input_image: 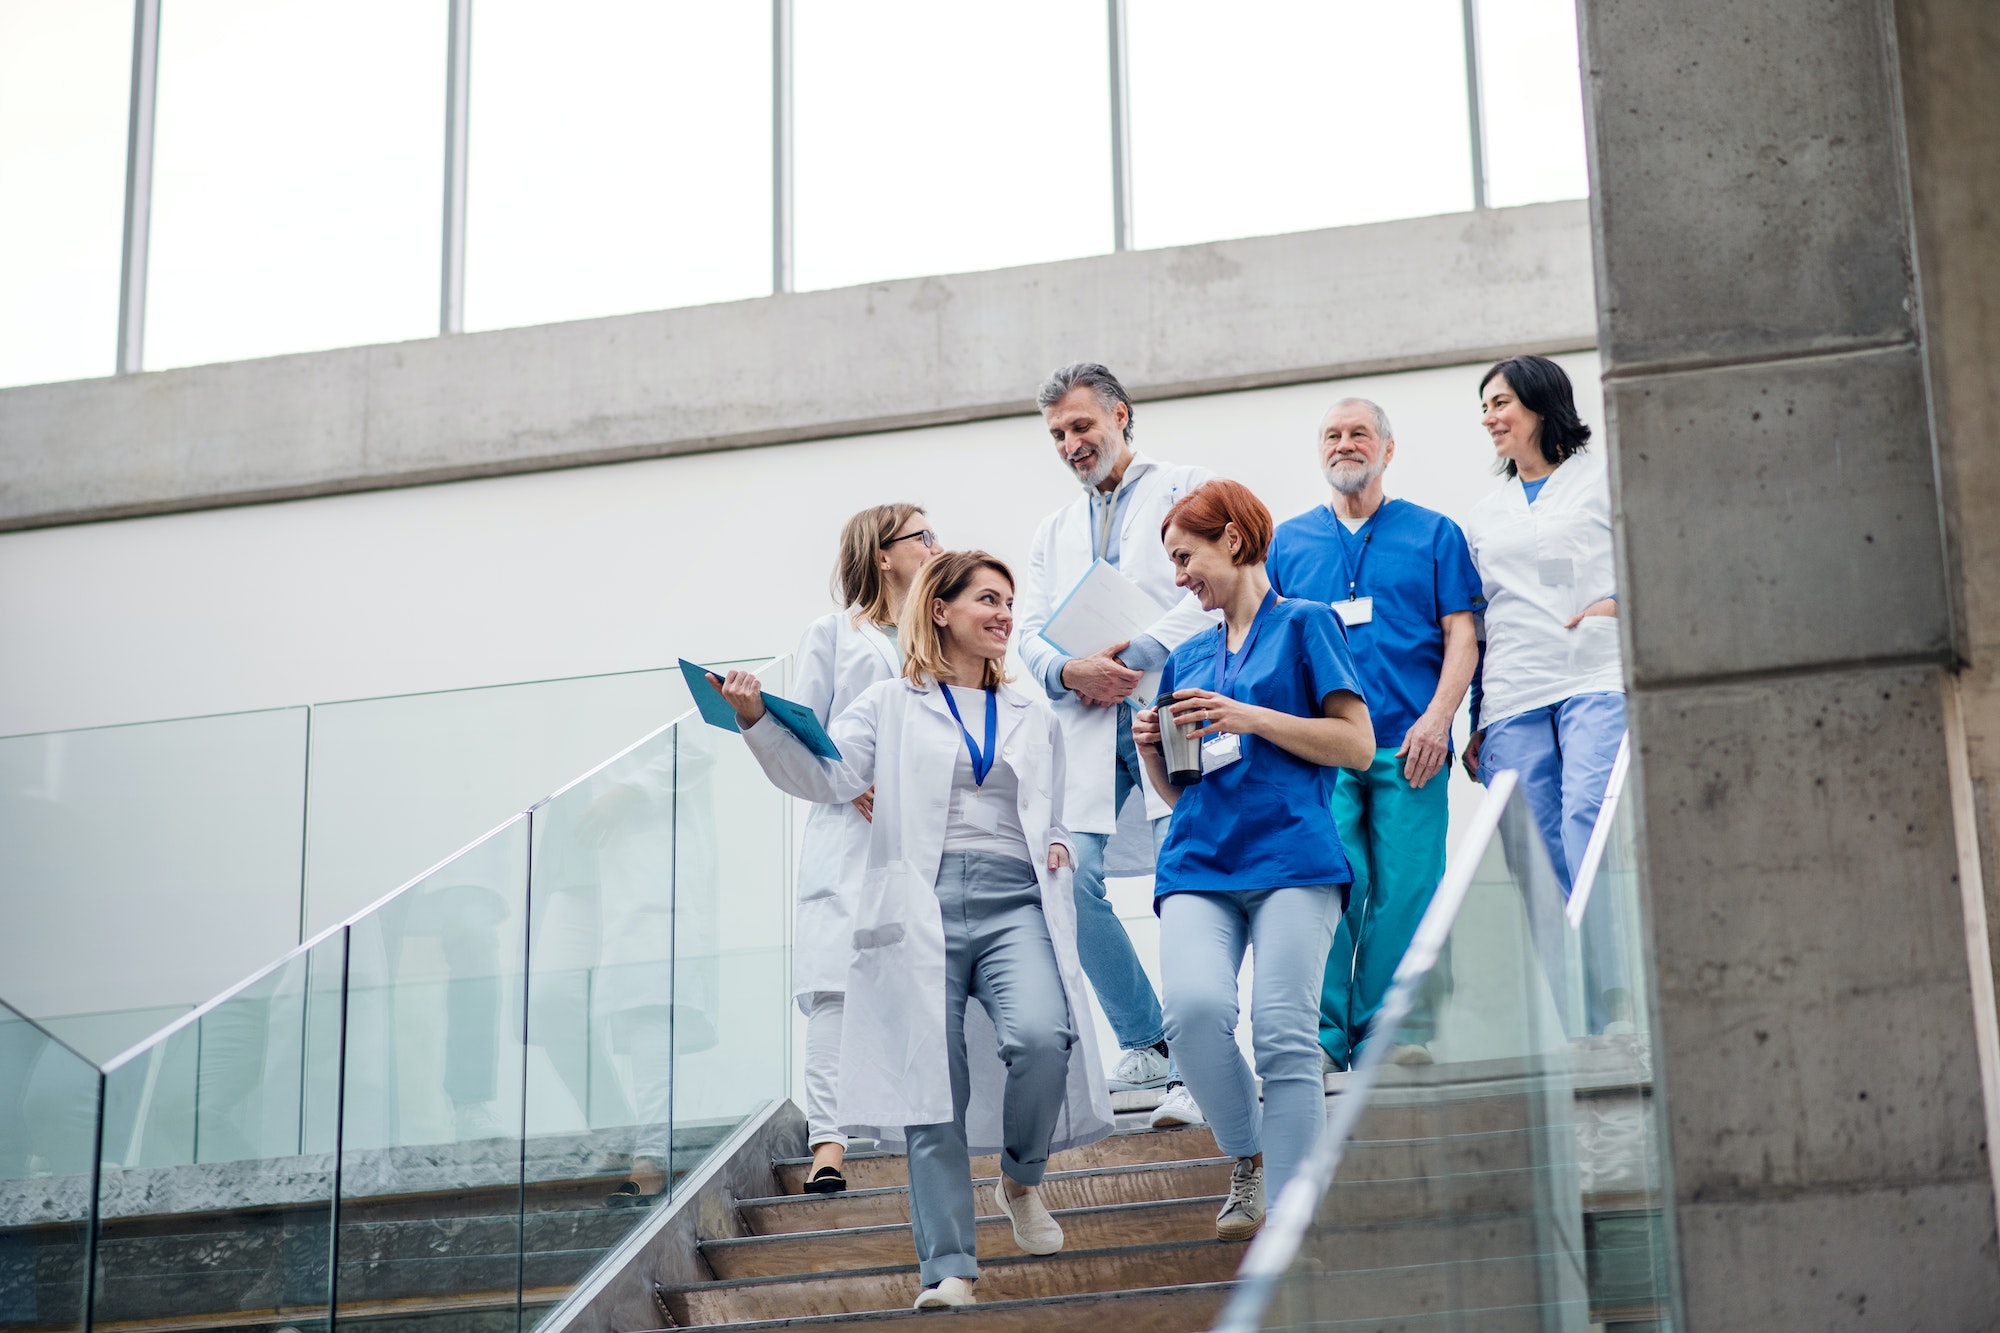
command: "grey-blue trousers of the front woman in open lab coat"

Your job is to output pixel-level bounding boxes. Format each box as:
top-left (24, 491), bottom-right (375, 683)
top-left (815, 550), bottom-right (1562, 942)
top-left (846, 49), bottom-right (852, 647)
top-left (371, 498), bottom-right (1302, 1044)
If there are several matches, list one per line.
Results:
top-left (904, 853), bottom-right (1076, 1287)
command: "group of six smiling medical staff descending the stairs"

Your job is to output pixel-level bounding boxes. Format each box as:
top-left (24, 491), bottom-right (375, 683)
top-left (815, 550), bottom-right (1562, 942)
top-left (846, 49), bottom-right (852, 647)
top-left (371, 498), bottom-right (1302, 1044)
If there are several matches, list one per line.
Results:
top-left (720, 356), bottom-right (1624, 1309)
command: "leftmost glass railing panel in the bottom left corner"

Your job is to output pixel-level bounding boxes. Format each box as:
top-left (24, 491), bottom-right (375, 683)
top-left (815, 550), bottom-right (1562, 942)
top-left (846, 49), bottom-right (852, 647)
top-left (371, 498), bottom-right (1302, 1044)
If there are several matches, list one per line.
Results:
top-left (0, 1005), bottom-right (102, 1333)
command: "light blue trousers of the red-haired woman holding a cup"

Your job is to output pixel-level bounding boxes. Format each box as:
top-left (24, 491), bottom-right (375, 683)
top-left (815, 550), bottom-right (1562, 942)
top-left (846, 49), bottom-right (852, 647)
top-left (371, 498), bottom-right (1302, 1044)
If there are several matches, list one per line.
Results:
top-left (1160, 885), bottom-right (1346, 1201)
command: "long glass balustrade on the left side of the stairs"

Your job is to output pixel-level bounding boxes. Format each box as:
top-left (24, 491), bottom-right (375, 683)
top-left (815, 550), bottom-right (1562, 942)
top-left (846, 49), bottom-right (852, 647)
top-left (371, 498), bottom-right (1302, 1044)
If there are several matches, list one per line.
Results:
top-left (0, 662), bottom-right (790, 1333)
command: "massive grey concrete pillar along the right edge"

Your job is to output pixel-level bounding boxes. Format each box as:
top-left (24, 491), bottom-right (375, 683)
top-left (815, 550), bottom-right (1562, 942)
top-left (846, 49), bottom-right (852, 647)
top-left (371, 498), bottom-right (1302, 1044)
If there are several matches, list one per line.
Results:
top-left (1580, 0), bottom-right (2000, 1333)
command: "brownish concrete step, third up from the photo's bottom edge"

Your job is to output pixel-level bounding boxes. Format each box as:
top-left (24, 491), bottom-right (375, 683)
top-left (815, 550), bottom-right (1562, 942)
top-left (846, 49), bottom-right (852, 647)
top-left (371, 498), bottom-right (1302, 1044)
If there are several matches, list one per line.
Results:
top-left (702, 1189), bottom-right (1222, 1279)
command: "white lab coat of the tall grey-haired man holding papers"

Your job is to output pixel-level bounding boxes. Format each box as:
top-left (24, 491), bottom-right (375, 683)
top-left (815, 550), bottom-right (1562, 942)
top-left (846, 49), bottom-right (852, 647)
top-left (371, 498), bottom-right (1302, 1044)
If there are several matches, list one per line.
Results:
top-left (1014, 452), bottom-right (1216, 833)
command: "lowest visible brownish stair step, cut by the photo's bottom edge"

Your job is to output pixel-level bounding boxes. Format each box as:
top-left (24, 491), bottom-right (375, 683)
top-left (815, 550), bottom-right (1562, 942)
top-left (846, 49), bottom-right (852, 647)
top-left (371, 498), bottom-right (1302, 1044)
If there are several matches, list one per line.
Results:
top-left (678, 1279), bottom-right (1232, 1333)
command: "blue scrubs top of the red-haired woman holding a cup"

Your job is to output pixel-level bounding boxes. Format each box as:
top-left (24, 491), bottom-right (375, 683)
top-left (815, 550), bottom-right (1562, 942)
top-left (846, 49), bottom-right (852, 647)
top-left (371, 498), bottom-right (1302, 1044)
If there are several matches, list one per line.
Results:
top-left (1152, 592), bottom-right (1362, 896)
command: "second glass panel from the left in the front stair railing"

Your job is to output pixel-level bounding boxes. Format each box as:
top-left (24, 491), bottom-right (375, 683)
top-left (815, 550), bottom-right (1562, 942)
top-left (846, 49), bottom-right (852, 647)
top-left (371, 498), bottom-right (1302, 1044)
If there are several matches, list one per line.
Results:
top-left (94, 935), bottom-right (346, 1329)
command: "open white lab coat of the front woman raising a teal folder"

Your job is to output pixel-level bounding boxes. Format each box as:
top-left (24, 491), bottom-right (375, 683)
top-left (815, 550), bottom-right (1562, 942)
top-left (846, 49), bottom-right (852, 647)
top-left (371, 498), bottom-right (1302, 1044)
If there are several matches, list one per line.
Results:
top-left (744, 679), bottom-right (1112, 1153)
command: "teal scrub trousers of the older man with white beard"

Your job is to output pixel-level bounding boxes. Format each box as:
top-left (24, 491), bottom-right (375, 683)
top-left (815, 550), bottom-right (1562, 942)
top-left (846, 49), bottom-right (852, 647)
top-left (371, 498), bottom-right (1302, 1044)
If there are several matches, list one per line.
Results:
top-left (1320, 749), bottom-right (1452, 1069)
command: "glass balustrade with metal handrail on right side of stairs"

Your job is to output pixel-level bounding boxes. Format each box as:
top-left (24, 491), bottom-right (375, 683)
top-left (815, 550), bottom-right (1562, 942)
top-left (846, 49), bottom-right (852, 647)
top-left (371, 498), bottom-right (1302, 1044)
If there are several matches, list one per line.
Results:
top-left (1216, 775), bottom-right (1674, 1333)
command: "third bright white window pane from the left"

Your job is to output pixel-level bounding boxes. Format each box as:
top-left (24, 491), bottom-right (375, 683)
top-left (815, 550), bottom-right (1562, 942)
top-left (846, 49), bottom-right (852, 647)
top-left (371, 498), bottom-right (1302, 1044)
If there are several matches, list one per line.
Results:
top-left (466, 0), bottom-right (772, 328)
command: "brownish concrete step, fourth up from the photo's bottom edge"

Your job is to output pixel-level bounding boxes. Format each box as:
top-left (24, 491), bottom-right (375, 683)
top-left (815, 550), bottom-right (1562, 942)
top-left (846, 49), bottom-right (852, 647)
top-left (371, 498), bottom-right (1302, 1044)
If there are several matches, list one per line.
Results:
top-left (736, 1157), bottom-right (1234, 1235)
